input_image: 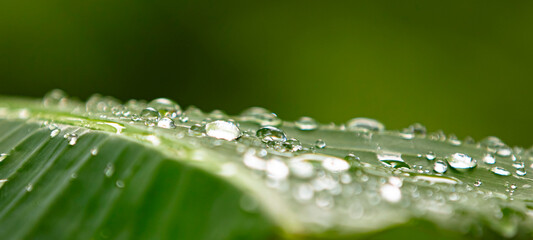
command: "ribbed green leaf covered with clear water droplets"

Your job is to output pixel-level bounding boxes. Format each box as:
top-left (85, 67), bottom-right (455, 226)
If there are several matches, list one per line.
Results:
top-left (0, 91), bottom-right (533, 239)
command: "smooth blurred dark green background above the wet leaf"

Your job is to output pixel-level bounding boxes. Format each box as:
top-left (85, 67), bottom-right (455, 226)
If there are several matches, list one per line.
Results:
top-left (0, 0), bottom-right (533, 147)
